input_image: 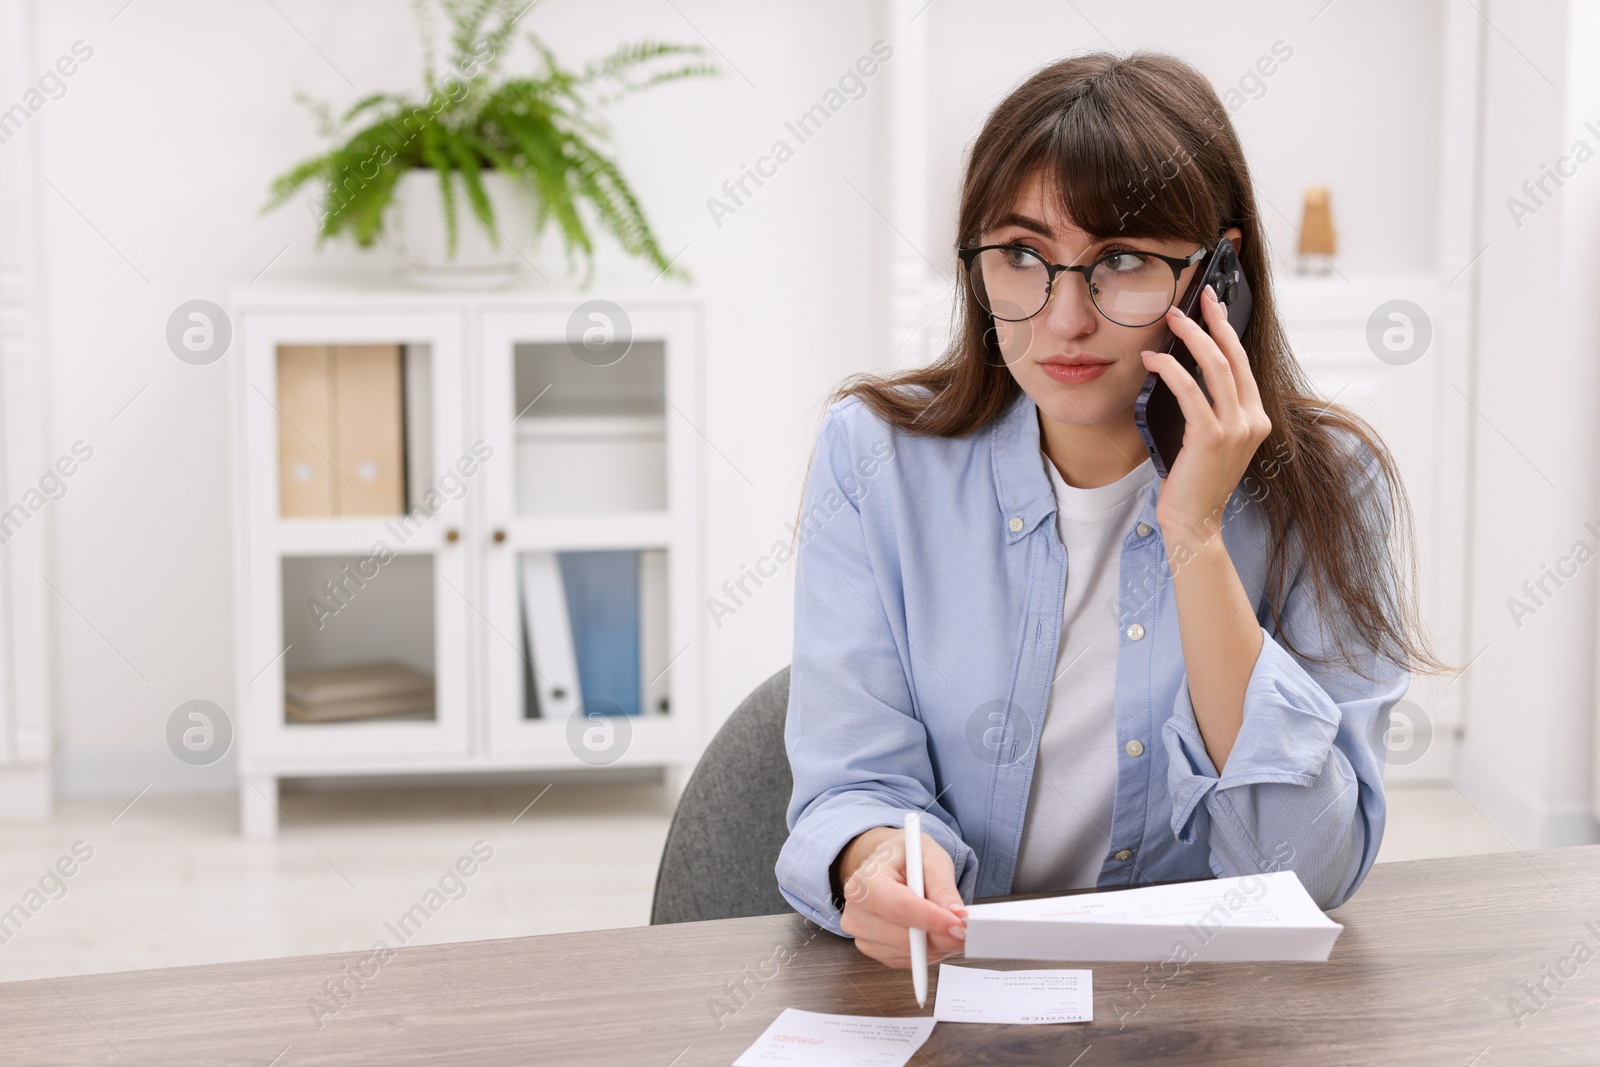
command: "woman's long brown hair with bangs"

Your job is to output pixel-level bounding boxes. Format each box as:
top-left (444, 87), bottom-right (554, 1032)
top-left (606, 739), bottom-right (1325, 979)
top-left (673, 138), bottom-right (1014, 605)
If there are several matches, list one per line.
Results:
top-left (830, 53), bottom-right (1458, 675)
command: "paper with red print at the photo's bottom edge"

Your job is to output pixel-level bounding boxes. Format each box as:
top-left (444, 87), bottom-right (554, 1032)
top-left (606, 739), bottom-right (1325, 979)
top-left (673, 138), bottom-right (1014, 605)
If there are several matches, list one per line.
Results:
top-left (733, 1011), bottom-right (942, 1067)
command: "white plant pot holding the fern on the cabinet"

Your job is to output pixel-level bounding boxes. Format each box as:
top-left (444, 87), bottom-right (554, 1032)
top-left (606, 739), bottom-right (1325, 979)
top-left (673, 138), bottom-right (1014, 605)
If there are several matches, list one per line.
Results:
top-left (394, 168), bottom-right (552, 290)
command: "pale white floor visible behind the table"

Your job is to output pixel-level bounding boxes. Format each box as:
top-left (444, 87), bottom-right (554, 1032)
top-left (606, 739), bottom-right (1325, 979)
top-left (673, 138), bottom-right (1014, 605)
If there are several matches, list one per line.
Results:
top-left (0, 781), bottom-right (1512, 981)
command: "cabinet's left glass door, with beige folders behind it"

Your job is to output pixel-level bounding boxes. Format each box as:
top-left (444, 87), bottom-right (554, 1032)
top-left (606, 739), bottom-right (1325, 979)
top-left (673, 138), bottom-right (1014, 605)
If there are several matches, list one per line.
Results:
top-left (242, 310), bottom-right (480, 771)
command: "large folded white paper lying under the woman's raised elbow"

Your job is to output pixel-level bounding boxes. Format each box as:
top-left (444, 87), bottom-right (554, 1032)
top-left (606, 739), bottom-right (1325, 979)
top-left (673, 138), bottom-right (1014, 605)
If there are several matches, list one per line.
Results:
top-left (965, 870), bottom-right (1344, 963)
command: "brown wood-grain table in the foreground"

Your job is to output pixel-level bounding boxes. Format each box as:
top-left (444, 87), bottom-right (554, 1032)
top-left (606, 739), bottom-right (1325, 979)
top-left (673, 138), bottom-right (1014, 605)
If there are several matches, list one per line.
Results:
top-left (0, 846), bottom-right (1600, 1067)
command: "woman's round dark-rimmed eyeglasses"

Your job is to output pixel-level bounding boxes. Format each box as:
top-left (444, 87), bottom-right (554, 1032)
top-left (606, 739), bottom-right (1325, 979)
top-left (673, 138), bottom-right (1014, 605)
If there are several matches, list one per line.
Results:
top-left (957, 245), bottom-right (1206, 326)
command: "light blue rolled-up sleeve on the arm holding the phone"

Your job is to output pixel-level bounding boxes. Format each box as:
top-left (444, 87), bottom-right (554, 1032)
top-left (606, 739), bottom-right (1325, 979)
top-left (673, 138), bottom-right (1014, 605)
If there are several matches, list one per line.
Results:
top-left (1162, 461), bottom-right (1411, 909)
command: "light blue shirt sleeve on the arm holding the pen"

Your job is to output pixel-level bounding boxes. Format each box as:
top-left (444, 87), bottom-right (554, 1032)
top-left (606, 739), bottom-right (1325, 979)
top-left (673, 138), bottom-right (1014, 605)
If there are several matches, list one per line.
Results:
top-left (774, 400), bottom-right (978, 936)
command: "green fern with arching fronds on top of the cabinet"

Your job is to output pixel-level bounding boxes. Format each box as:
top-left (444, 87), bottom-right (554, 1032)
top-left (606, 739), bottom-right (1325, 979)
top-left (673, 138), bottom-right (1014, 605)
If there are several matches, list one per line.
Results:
top-left (262, 0), bottom-right (720, 283)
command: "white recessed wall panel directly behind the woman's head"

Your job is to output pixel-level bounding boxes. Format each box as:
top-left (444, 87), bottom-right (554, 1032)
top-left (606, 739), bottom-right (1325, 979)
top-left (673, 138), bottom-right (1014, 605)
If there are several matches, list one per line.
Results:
top-left (925, 0), bottom-right (1440, 274)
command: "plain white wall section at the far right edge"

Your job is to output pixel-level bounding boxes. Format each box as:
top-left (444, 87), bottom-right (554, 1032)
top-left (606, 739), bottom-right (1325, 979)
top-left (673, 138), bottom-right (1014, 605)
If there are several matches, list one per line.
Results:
top-left (1458, 0), bottom-right (1600, 848)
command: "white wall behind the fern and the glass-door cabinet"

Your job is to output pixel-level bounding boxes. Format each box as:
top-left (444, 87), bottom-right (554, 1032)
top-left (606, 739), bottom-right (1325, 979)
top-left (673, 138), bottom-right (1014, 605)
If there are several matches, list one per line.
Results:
top-left (22, 0), bottom-right (882, 792)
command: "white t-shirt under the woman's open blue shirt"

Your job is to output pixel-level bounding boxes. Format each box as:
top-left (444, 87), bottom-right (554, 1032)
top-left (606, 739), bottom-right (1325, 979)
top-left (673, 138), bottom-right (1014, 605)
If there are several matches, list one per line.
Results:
top-left (1011, 453), bottom-right (1157, 893)
